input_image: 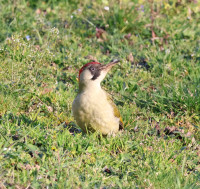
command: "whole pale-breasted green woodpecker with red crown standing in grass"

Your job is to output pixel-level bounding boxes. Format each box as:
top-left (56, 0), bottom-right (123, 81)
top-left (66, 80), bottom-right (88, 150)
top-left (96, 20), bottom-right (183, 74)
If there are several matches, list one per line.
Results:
top-left (72, 60), bottom-right (124, 135)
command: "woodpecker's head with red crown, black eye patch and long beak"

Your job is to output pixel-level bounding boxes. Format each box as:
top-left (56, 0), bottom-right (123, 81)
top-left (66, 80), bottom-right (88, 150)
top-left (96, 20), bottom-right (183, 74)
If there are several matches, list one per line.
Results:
top-left (79, 60), bottom-right (119, 89)
